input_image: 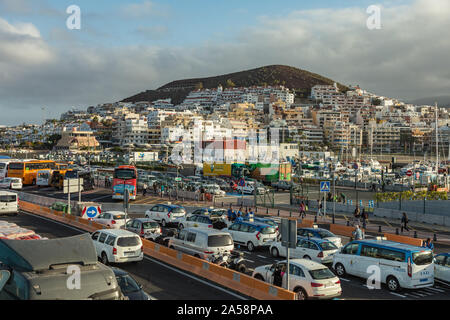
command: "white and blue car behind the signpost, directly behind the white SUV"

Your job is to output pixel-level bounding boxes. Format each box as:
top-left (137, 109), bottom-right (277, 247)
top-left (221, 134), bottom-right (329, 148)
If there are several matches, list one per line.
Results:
top-left (269, 237), bottom-right (339, 264)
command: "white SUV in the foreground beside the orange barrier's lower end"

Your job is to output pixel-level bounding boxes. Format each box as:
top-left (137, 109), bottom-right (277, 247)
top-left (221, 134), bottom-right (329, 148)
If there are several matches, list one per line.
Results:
top-left (252, 259), bottom-right (342, 300)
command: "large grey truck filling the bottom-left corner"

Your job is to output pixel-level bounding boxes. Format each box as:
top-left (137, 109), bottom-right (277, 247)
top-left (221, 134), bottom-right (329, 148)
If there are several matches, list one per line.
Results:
top-left (0, 233), bottom-right (125, 300)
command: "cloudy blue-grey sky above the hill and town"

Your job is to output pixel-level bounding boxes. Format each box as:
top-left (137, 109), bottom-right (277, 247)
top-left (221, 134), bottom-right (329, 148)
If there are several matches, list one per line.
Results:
top-left (0, 0), bottom-right (450, 125)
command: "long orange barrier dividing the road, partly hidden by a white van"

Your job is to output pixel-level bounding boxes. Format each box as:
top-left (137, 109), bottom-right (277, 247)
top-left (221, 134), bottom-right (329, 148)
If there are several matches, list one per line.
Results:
top-left (20, 200), bottom-right (295, 300)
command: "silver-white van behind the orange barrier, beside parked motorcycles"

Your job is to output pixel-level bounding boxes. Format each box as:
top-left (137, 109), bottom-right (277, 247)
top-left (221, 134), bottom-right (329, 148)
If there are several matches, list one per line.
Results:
top-left (169, 228), bottom-right (234, 260)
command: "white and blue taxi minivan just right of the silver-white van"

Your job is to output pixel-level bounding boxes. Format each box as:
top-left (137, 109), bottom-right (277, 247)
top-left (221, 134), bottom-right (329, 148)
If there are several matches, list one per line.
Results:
top-left (222, 221), bottom-right (278, 251)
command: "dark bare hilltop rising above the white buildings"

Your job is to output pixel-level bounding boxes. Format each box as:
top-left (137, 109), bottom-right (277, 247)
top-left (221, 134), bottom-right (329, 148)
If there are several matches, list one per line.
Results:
top-left (123, 65), bottom-right (348, 104)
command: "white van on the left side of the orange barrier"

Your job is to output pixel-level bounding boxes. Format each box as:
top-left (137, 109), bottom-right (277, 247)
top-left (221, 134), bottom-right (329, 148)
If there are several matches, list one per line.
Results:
top-left (91, 229), bottom-right (144, 264)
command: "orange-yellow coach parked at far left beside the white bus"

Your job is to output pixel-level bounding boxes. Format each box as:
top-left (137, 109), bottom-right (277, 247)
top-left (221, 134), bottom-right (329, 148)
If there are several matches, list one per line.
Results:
top-left (8, 160), bottom-right (56, 185)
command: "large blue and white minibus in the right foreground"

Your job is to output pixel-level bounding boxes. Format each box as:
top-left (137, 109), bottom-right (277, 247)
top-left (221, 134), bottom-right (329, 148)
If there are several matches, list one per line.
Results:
top-left (333, 238), bottom-right (434, 292)
